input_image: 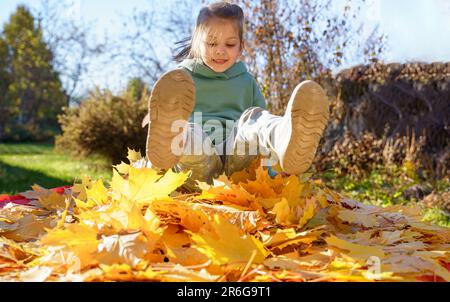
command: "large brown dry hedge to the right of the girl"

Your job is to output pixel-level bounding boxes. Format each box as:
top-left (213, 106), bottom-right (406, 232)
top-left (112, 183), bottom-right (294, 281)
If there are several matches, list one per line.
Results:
top-left (319, 62), bottom-right (450, 179)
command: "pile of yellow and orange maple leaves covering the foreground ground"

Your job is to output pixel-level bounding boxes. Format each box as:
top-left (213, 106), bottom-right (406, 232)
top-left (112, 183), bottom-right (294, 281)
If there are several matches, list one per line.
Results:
top-left (0, 150), bottom-right (450, 281)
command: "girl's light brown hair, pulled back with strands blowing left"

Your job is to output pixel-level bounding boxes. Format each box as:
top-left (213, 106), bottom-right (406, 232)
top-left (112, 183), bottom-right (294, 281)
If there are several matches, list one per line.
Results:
top-left (173, 1), bottom-right (244, 62)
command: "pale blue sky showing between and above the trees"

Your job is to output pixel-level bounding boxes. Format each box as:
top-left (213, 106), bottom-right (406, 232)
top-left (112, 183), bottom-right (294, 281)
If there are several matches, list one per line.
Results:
top-left (0, 0), bottom-right (450, 94)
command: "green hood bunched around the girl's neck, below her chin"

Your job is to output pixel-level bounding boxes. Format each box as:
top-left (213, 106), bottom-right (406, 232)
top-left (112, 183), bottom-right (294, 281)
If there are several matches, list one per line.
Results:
top-left (179, 59), bottom-right (247, 80)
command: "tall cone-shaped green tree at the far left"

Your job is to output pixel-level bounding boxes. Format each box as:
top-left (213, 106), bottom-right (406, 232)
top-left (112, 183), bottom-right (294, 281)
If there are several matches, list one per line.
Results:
top-left (3, 6), bottom-right (67, 139)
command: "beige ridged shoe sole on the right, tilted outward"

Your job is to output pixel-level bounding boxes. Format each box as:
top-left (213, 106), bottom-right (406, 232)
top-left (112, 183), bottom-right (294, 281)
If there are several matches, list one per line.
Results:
top-left (280, 81), bottom-right (330, 174)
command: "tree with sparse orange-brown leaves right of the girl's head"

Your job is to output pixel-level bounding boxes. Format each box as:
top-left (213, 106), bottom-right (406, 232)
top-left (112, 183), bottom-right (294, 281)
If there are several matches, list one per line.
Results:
top-left (236, 0), bottom-right (385, 114)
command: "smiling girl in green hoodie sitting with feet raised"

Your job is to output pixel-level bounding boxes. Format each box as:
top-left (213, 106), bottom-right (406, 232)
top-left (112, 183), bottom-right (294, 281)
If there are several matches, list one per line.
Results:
top-left (147, 2), bottom-right (329, 190)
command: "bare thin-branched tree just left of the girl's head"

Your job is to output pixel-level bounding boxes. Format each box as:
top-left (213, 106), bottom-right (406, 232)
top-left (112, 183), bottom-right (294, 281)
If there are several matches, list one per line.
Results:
top-left (108, 0), bottom-right (200, 87)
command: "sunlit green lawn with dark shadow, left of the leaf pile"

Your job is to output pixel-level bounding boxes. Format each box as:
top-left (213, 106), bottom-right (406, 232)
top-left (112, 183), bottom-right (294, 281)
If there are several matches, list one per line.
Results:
top-left (0, 143), bottom-right (112, 195)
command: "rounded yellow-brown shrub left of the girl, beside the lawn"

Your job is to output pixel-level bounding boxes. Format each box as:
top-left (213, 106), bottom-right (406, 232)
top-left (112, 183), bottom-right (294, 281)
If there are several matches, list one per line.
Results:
top-left (56, 91), bottom-right (148, 163)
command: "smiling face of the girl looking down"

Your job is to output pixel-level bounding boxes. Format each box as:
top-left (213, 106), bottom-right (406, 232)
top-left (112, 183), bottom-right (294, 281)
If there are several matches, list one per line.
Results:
top-left (200, 19), bottom-right (242, 72)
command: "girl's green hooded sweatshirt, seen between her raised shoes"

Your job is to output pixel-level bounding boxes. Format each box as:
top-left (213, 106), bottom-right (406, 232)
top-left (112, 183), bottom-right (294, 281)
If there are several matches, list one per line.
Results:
top-left (179, 59), bottom-right (267, 144)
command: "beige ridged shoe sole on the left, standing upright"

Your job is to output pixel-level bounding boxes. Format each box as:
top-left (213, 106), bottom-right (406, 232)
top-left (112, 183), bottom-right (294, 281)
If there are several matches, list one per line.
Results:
top-left (146, 69), bottom-right (195, 169)
